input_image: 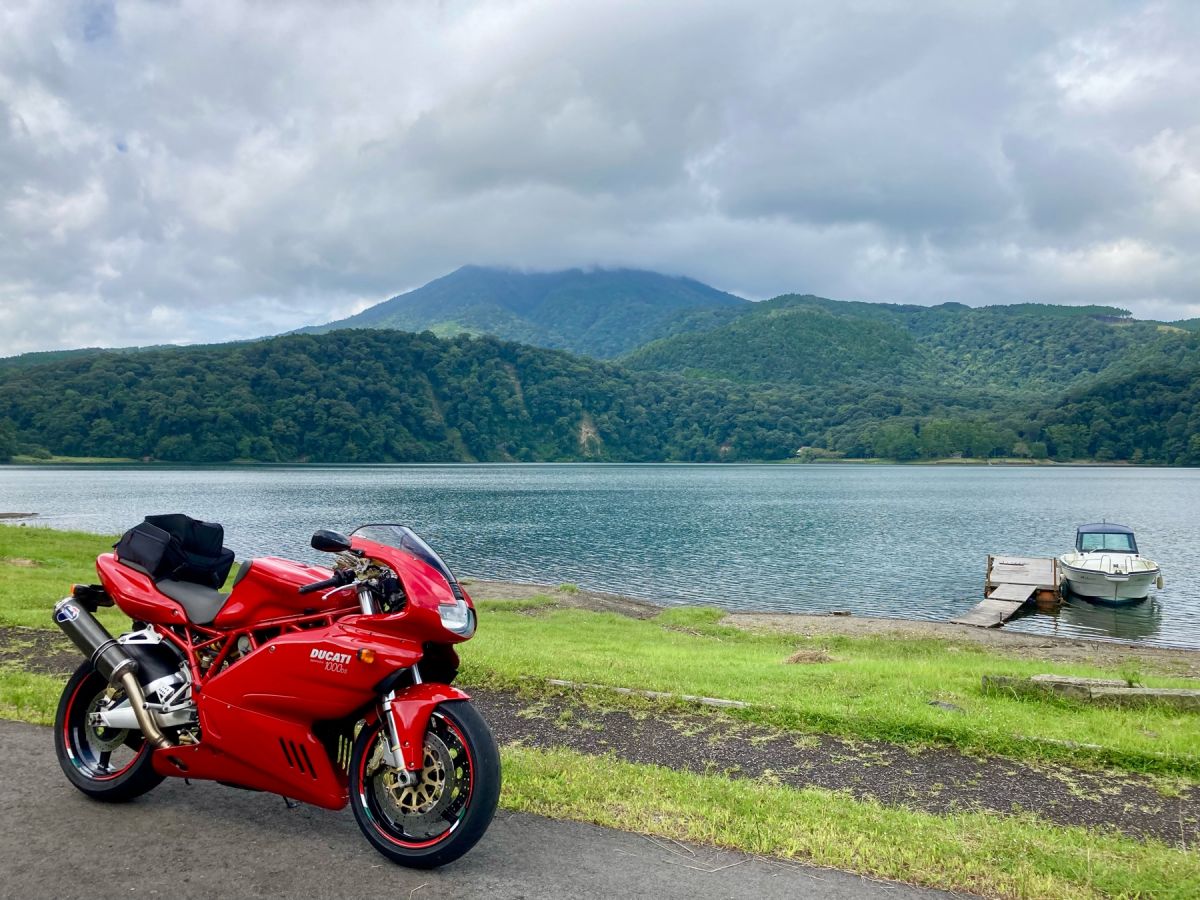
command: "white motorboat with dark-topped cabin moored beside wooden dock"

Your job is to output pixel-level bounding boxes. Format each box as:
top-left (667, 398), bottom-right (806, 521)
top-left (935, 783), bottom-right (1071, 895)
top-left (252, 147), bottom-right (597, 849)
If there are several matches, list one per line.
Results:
top-left (1058, 522), bottom-right (1163, 604)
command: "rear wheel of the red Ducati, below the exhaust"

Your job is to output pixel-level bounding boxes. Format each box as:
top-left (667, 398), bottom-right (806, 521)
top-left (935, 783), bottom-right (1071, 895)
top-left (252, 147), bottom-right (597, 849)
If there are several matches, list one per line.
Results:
top-left (54, 662), bottom-right (163, 803)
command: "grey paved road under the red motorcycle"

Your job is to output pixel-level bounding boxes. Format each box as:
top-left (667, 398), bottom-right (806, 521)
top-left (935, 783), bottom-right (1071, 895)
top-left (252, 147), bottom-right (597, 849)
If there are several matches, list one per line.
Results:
top-left (0, 721), bottom-right (942, 900)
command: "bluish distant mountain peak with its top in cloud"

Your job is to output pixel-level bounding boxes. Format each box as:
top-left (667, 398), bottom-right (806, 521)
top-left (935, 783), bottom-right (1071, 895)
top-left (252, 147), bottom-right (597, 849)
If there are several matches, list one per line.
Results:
top-left (302, 265), bottom-right (749, 359)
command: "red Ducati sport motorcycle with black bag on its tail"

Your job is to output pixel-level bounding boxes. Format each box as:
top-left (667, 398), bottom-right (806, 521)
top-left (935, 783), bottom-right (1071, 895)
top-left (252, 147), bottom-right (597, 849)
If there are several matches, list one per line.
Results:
top-left (54, 516), bottom-right (500, 868)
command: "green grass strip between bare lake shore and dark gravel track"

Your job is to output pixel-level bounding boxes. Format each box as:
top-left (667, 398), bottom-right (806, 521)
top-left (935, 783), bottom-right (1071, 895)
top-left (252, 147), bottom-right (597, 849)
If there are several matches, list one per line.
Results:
top-left (462, 601), bottom-right (1200, 780)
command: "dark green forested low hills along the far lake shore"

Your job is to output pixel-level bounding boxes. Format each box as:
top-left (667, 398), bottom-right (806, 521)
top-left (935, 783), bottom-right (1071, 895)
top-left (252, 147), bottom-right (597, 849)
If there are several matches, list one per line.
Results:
top-left (0, 324), bottom-right (1200, 466)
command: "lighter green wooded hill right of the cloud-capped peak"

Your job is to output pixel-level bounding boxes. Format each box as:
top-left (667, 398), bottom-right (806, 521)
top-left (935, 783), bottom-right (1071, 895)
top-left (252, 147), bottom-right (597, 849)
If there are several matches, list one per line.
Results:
top-left (622, 295), bottom-right (1200, 396)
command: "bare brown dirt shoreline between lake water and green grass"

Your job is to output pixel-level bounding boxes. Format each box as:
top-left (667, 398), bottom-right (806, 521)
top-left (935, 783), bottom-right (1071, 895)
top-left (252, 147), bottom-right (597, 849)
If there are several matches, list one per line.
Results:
top-left (461, 576), bottom-right (1200, 678)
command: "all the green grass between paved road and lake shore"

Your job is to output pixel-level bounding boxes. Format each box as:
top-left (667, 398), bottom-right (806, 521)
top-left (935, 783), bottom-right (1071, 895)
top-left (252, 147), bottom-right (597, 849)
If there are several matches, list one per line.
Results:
top-left (0, 526), bottom-right (1200, 898)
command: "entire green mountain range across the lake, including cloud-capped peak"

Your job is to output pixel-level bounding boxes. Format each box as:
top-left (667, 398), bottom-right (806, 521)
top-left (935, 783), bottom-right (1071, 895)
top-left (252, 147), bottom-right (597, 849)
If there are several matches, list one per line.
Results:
top-left (7, 269), bottom-right (1200, 464)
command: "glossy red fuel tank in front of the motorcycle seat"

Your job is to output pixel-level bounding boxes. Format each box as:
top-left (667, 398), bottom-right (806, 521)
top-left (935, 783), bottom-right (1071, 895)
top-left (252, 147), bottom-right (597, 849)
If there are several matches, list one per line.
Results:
top-left (212, 557), bottom-right (358, 629)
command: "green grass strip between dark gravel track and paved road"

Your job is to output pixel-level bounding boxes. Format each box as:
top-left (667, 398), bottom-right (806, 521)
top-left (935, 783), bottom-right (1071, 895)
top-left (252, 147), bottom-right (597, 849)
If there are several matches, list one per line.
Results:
top-left (502, 745), bottom-right (1200, 898)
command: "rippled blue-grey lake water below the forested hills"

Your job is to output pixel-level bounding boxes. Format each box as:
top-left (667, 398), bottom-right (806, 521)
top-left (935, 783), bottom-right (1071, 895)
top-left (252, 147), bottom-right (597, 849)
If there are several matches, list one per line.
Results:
top-left (0, 464), bottom-right (1200, 647)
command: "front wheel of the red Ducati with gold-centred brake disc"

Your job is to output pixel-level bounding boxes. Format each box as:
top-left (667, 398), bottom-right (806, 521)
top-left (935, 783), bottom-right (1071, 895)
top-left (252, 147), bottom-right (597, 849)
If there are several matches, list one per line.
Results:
top-left (350, 700), bottom-right (500, 869)
